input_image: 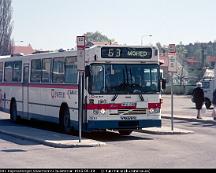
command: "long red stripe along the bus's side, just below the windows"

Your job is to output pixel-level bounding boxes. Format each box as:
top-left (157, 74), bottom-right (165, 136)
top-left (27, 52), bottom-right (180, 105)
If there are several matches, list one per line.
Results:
top-left (0, 83), bottom-right (78, 89)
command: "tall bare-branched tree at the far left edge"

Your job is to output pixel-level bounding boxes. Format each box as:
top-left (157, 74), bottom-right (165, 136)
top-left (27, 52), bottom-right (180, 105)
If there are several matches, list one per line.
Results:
top-left (0, 0), bottom-right (13, 55)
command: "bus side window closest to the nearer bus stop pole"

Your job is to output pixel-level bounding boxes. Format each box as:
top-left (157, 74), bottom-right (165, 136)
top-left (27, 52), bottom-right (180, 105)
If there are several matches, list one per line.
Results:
top-left (65, 57), bottom-right (77, 84)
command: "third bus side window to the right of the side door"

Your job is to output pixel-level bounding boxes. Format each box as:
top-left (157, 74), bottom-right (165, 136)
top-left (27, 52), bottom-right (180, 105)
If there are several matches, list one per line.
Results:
top-left (52, 57), bottom-right (65, 83)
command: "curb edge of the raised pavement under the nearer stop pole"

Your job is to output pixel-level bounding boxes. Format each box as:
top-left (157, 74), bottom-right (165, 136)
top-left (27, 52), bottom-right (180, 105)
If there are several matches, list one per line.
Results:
top-left (0, 129), bottom-right (106, 148)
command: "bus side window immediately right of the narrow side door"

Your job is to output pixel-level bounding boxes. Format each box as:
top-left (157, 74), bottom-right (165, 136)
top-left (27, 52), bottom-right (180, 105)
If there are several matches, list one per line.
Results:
top-left (31, 59), bottom-right (41, 83)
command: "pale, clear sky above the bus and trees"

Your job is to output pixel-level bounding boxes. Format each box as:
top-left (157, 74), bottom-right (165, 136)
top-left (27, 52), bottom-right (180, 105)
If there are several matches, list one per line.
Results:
top-left (12, 0), bottom-right (216, 50)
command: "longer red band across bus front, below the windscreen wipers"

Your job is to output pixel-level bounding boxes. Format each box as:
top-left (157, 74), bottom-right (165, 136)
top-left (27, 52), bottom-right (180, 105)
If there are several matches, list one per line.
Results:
top-left (86, 104), bottom-right (136, 110)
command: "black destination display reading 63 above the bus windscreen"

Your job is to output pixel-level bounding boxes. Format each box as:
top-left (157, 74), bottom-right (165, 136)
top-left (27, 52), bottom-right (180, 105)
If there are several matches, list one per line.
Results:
top-left (101, 47), bottom-right (152, 59)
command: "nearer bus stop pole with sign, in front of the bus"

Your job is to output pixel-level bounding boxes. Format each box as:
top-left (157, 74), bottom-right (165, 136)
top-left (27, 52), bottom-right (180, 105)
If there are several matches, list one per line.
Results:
top-left (77, 36), bottom-right (85, 143)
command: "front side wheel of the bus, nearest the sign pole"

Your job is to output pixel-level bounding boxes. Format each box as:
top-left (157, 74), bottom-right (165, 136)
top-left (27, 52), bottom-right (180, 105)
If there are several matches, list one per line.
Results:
top-left (59, 106), bottom-right (71, 133)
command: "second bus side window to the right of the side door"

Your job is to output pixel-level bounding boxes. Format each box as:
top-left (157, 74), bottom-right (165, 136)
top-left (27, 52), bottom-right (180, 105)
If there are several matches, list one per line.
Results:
top-left (42, 58), bottom-right (52, 83)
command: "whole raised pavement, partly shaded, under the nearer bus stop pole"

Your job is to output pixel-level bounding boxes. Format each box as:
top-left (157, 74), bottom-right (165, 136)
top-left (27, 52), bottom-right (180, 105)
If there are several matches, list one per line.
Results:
top-left (0, 124), bottom-right (105, 148)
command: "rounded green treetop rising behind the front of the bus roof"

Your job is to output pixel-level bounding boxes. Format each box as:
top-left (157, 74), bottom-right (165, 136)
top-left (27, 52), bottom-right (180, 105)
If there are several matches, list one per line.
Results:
top-left (84, 31), bottom-right (114, 43)
